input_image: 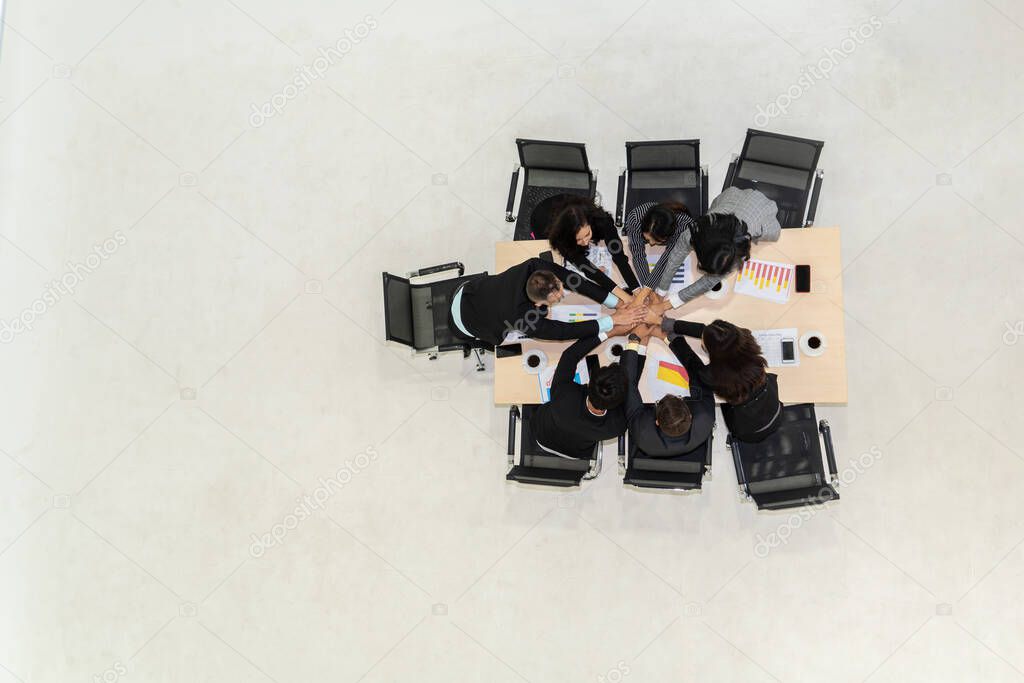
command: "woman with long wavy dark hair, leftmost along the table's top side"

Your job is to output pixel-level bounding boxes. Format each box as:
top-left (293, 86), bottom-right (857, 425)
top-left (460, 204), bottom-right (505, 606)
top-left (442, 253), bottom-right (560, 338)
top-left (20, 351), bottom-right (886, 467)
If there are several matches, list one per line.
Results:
top-left (548, 195), bottom-right (639, 303)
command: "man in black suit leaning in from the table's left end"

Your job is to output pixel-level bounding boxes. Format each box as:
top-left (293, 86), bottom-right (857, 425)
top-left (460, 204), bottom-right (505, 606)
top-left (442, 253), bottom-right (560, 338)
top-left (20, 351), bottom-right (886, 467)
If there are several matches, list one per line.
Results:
top-left (449, 258), bottom-right (646, 346)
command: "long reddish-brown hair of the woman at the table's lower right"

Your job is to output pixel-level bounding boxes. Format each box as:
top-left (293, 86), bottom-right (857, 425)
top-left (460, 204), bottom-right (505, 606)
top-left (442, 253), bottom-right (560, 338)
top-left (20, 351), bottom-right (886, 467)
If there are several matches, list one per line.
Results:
top-left (702, 321), bottom-right (768, 405)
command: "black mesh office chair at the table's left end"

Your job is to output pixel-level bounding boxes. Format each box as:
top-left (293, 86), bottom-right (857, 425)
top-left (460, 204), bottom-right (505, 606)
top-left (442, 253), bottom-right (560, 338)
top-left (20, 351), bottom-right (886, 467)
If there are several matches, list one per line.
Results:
top-left (383, 261), bottom-right (492, 372)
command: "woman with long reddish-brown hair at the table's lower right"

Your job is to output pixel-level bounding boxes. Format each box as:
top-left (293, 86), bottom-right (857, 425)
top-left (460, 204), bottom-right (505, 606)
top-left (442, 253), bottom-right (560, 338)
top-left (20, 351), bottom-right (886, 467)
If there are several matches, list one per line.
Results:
top-left (662, 317), bottom-right (782, 441)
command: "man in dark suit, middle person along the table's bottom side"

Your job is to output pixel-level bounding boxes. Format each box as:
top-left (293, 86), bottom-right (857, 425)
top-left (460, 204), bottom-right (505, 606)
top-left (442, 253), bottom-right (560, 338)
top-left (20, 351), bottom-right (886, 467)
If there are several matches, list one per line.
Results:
top-left (622, 328), bottom-right (715, 458)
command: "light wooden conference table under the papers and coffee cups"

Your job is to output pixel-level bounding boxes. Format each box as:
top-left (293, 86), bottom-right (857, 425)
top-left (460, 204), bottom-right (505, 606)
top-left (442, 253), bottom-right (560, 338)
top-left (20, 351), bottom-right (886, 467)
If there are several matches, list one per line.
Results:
top-left (495, 227), bottom-right (847, 404)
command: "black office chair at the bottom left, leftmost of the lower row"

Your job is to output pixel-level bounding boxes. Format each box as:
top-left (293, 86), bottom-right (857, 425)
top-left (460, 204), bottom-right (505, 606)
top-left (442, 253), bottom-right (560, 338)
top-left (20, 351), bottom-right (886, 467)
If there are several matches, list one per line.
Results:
top-left (505, 405), bottom-right (601, 486)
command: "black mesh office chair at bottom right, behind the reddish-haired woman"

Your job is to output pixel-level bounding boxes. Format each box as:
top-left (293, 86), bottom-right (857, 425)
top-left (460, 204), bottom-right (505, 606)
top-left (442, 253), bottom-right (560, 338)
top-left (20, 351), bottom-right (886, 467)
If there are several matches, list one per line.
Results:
top-left (727, 403), bottom-right (839, 510)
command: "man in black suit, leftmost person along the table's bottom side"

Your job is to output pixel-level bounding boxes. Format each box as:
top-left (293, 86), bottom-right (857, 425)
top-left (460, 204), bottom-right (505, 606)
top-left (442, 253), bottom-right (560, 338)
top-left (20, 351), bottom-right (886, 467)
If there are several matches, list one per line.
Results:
top-left (532, 335), bottom-right (627, 460)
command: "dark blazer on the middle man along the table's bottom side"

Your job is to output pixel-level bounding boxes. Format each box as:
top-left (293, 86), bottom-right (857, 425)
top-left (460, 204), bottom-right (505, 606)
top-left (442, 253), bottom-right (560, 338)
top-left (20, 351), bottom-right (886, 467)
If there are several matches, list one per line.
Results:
top-left (622, 337), bottom-right (715, 458)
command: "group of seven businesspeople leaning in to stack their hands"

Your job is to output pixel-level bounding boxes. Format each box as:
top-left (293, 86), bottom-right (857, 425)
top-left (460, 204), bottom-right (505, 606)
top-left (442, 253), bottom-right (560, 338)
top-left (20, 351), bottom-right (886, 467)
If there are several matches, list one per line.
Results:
top-left (449, 187), bottom-right (781, 459)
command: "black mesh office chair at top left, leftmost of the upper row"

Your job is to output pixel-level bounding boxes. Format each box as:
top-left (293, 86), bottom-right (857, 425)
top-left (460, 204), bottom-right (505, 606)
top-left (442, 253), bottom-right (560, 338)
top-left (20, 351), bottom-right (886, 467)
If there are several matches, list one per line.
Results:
top-left (505, 138), bottom-right (597, 240)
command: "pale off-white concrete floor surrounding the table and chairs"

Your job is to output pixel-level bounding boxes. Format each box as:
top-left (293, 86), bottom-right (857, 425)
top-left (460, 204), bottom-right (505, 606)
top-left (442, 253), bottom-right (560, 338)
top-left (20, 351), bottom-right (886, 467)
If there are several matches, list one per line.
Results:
top-left (0, 0), bottom-right (1024, 683)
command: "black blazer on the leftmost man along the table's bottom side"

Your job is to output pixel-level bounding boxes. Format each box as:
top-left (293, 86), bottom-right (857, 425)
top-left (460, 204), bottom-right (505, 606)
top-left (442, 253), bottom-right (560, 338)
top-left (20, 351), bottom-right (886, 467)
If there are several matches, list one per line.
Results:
top-left (532, 336), bottom-right (626, 459)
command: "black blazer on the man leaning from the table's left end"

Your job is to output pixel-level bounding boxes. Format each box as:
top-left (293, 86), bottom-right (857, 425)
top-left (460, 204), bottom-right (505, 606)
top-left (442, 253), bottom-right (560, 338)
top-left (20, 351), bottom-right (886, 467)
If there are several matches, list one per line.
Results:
top-left (460, 258), bottom-right (610, 345)
